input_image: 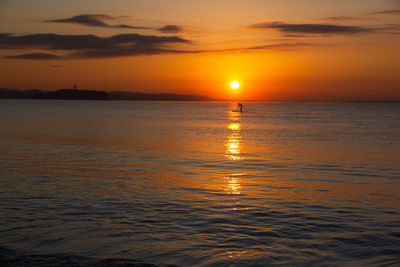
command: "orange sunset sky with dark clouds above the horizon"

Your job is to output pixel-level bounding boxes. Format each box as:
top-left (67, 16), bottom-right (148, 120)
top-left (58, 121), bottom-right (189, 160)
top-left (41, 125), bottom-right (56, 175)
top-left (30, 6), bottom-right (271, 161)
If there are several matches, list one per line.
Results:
top-left (0, 0), bottom-right (400, 101)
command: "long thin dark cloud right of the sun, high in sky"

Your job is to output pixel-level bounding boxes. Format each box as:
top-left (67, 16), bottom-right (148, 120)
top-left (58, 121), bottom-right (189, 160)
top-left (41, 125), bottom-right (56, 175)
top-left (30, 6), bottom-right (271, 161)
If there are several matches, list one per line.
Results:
top-left (249, 21), bottom-right (373, 35)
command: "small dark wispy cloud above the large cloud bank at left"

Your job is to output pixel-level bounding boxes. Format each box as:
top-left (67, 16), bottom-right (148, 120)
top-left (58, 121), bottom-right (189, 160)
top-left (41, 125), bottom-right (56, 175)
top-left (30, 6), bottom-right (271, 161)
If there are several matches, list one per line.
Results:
top-left (45, 14), bottom-right (147, 29)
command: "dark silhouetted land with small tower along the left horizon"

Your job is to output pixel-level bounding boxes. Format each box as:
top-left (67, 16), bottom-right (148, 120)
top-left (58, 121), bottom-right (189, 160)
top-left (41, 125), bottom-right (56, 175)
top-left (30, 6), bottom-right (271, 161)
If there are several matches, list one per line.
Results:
top-left (0, 88), bottom-right (215, 101)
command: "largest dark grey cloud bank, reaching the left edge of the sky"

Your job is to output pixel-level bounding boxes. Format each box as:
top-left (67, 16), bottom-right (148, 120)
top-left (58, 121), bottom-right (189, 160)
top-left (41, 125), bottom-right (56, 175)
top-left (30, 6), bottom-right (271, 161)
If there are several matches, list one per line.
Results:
top-left (0, 34), bottom-right (191, 59)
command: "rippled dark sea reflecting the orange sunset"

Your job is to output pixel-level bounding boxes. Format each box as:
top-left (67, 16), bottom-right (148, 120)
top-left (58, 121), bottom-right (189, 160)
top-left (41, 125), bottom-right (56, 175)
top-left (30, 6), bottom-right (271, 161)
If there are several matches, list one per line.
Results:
top-left (0, 100), bottom-right (400, 266)
